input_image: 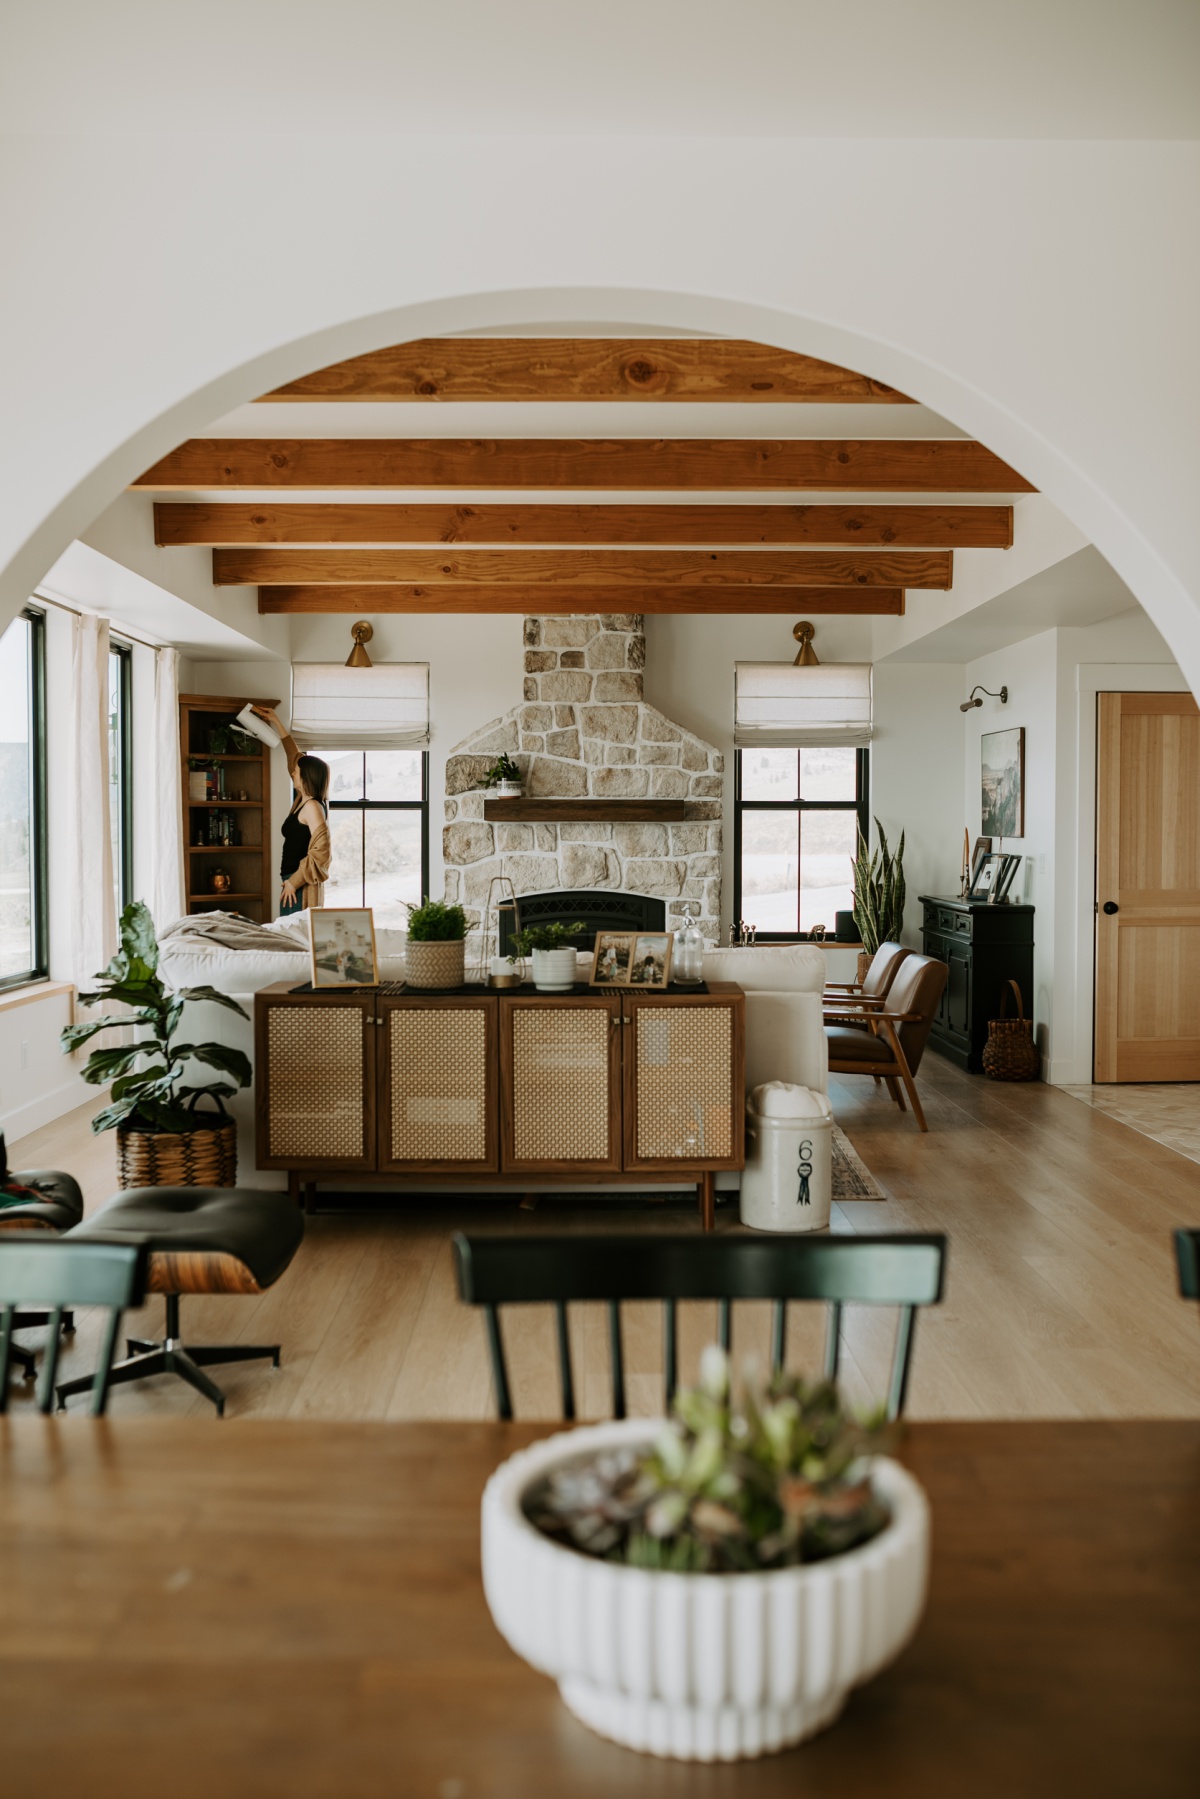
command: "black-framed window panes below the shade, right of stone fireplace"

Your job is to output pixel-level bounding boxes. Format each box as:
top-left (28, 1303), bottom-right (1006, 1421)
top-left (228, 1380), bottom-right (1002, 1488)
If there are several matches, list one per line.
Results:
top-left (734, 747), bottom-right (869, 943)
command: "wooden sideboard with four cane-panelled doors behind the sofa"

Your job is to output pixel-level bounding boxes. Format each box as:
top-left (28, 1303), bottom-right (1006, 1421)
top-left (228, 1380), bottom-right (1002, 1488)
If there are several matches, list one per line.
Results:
top-left (254, 982), bottom-right (745, 1227)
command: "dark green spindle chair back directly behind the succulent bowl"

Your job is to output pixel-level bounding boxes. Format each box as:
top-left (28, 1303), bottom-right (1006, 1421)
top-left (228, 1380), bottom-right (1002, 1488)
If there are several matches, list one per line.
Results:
top-left (453, 1232), bottom-right (946, 1419)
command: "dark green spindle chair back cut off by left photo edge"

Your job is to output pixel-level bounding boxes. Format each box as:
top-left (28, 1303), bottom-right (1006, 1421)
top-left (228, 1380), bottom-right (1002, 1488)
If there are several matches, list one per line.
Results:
top-left (0, 1232), bottom-right (149, 1418)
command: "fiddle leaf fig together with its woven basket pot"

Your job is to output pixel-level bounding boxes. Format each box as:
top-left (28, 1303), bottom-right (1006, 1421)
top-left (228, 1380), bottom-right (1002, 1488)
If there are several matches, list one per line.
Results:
top-left (59, 900), bottom-right (250, 1187)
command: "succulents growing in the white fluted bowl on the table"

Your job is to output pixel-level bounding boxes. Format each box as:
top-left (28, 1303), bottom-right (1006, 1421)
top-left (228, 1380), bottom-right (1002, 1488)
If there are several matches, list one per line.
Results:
top-left (524, 1347), bottom-right (894, 1574)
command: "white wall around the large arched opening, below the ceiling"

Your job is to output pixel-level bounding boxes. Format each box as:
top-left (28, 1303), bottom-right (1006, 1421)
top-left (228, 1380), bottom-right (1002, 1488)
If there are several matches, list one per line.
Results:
top-left (0, 138), bottom-right (1200, 682)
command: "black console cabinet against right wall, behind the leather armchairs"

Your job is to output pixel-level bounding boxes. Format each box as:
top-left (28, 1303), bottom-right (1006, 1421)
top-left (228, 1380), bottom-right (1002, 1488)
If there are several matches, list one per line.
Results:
top-left (921, 894), bottom-right (1033, 1072)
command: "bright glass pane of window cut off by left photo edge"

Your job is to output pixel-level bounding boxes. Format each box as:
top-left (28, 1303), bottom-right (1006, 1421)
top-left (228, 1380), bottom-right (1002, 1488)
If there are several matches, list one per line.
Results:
top-left (0, 619), bottom-right (36, 980)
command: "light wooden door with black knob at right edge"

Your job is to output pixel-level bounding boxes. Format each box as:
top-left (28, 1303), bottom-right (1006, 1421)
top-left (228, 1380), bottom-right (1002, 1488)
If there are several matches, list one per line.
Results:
top-left (1094, 693), bottom-right (1200, 1081)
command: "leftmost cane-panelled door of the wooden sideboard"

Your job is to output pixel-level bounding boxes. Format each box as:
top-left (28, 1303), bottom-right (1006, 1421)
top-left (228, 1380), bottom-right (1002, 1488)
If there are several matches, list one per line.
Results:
top-left (254, 993), bottom-right (378, 1173)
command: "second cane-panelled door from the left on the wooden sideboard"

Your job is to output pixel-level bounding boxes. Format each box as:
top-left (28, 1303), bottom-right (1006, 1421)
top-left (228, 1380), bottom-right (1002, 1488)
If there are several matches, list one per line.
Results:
top-left (378, 995), bottom-right (500, 1175)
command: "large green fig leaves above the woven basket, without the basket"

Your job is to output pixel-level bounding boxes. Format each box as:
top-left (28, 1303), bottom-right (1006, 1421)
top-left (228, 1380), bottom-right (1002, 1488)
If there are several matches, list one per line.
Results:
top-left (59, 900), bottom-right (252, 1132)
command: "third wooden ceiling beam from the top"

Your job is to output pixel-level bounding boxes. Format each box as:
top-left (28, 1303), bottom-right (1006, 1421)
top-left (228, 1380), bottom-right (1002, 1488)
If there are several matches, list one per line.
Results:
top-left (155, 500), bottom-right (1013, 550)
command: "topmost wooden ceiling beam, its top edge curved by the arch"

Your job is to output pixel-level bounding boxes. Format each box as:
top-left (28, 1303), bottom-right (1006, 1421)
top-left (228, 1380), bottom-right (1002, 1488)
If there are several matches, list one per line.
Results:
top-left (253, 338), bottom-right (912, 407)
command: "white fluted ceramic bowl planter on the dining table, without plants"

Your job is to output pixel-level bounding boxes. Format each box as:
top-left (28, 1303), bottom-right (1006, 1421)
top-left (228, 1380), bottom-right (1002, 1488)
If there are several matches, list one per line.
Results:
top-left (482, 1418), bottom-right (928, 1761)
